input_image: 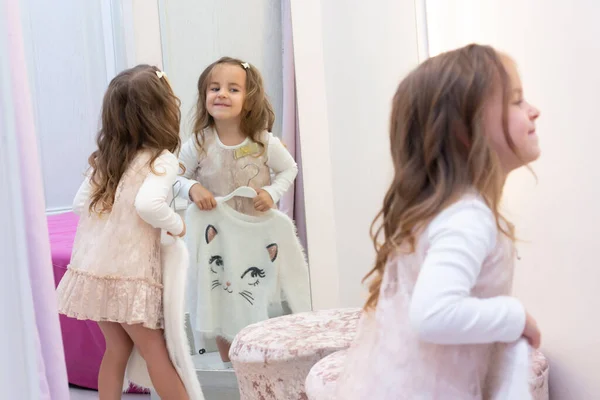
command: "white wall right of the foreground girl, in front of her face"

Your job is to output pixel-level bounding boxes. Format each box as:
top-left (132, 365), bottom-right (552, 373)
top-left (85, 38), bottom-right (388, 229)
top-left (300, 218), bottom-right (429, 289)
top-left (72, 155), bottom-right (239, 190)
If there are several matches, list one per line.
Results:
top-left (427, 0), bottom-right (600, 400)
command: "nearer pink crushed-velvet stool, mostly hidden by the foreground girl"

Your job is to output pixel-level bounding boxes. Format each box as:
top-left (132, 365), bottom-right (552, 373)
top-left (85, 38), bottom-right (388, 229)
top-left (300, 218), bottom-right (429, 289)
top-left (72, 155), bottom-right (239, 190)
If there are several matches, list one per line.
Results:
top-left (306, 350), bottom-right (549, 400)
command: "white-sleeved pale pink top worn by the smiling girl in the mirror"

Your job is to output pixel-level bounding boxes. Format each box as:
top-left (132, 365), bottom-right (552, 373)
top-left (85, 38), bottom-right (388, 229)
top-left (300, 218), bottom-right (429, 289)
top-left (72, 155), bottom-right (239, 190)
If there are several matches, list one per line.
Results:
top-left (179, 129), bottom-right (298, 203)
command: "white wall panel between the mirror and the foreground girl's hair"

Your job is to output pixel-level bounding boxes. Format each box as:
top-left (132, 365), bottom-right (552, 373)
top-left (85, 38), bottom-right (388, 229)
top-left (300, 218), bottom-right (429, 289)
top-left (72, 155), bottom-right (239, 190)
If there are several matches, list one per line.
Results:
top-left (318, 0), bottom-right (418, 306)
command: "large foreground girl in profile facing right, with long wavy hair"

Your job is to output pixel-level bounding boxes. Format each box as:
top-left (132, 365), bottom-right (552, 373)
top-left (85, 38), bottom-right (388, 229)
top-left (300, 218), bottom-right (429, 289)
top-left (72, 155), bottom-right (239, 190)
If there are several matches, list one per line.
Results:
top-left (337, 45), bottom-right (540, 400)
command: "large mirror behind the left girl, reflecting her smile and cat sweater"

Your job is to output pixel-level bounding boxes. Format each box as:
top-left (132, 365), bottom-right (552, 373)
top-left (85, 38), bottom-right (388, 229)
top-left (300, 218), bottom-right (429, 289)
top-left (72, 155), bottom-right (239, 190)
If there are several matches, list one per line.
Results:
top-left (22, 0), bottom-right (316, 391)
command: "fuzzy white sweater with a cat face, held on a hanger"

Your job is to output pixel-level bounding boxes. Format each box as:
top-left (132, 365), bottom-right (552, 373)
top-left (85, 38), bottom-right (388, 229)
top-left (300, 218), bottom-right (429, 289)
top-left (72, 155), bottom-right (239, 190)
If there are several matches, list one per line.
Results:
top-left (186, 203), bottom-right (311, 340)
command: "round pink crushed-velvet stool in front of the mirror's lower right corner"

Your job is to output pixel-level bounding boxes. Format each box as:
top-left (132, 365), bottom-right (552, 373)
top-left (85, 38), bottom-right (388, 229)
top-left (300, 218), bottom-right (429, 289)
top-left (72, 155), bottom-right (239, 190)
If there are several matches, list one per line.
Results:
top-left (229, 308), bottom-right (361, 400)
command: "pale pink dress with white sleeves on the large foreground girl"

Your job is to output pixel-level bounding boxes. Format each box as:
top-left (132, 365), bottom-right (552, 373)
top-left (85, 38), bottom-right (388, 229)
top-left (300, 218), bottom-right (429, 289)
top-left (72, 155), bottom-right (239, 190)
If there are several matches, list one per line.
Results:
top-left (334, 195), bottom-right (531, 400)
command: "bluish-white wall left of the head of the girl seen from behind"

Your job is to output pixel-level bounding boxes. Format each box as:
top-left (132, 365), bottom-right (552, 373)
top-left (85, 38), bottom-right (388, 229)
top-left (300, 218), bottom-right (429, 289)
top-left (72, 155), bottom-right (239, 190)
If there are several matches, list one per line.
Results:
top-left (22, 0), bottom-right (107, 211)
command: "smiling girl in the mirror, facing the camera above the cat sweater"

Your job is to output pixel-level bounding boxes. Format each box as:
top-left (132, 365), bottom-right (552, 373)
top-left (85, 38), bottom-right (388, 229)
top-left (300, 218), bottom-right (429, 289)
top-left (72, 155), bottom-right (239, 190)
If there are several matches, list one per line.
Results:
top-left (179, 57), bottom-right (298, 215)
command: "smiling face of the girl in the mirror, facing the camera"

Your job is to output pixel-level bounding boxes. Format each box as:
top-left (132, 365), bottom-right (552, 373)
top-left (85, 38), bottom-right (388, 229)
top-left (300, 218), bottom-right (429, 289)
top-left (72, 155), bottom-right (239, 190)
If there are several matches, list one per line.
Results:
top-left (206, 64), bottom-right (246, 121)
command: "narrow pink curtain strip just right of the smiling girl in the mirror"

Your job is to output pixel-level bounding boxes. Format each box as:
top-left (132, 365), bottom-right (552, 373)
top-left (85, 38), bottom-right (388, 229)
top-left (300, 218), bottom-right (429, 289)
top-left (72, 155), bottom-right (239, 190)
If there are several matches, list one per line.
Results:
top-left (280, 0), bottom-right (306, 248)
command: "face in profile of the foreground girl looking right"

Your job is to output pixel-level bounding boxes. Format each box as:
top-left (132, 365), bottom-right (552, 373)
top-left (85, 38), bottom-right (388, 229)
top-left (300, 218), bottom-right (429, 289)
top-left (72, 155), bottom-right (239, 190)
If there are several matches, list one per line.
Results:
top-left (484, 57), bottom-right (540, 174)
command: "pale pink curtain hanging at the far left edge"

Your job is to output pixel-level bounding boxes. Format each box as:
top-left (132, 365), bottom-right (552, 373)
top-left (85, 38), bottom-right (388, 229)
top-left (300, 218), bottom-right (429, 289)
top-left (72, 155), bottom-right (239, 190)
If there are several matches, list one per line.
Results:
top-left (0, 0), bottom-right (69, 400)
